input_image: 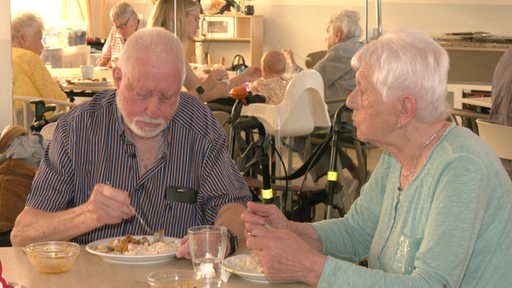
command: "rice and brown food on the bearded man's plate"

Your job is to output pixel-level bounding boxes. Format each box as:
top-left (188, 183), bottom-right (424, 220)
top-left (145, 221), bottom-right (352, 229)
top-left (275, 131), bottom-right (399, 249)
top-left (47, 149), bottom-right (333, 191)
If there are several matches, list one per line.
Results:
top-left (95, 235), bottom-right (180, 255)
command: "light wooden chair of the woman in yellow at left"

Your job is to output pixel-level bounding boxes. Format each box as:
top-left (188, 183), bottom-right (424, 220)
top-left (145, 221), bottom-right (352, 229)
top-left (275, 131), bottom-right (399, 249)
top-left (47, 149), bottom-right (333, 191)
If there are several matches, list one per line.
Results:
top-left (13, 95), bottom-right (77, 131)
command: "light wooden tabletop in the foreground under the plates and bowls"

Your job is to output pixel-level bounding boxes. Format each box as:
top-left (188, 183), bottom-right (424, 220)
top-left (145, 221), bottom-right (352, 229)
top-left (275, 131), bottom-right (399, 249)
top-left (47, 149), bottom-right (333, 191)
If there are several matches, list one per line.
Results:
top-left (0, 246), bottom-right (307, 288)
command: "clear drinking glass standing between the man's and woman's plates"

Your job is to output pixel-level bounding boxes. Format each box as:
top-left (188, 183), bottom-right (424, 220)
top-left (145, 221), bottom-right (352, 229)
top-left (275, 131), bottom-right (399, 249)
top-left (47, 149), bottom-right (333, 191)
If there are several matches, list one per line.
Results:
top-left (188, 225), bottom-right (228, 287)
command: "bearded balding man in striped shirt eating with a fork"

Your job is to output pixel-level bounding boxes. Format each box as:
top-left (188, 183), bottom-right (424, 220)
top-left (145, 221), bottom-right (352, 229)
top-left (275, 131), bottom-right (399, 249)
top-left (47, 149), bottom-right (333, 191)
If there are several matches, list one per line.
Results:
top-left (11, 28), bottom-right (252, 256)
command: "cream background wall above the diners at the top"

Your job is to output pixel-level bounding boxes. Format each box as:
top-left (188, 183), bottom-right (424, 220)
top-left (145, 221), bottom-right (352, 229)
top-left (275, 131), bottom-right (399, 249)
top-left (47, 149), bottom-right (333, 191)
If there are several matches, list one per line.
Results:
top-left (100, 0), bottom-right (512, 68)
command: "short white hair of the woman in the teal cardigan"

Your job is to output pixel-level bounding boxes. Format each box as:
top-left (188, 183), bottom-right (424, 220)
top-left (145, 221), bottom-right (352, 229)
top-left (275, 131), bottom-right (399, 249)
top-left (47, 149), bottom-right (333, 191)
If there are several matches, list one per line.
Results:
top-left (351, 29), bottom-right (450, 123)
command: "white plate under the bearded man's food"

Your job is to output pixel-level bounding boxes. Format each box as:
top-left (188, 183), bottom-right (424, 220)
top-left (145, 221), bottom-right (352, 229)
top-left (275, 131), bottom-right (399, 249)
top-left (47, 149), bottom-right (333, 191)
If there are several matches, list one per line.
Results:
top-left (85, 236), bottom-right (180, 264)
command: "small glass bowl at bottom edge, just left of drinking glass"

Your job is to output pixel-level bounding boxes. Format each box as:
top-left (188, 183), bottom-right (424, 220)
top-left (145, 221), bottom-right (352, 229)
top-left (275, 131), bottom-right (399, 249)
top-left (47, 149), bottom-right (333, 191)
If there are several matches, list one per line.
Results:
top-left (147, 269), bottom-right (202, 288)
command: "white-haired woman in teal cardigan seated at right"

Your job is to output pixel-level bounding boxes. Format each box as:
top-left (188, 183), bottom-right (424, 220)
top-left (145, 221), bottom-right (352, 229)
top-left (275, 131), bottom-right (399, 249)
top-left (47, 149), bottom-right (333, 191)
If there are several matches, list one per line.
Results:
top-left (241, 30), bottom-right (512, 287)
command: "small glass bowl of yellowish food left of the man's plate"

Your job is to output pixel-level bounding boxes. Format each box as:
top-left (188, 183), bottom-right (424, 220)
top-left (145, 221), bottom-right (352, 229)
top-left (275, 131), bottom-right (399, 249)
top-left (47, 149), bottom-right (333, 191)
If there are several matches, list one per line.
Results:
top-left (24, 241), bottom-right (80, 273)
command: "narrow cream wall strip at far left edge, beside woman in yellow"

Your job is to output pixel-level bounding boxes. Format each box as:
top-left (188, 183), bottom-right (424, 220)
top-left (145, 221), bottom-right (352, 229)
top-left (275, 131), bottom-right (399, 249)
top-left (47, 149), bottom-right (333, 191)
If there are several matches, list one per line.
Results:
top-left (0, 1), bottom-right (12, 131)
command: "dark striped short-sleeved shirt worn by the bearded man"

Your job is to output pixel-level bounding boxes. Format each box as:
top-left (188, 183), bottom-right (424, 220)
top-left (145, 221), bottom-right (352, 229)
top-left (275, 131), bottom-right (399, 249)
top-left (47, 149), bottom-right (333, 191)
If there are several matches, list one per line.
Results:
top-left (27, 90), bottom-right (251, 244)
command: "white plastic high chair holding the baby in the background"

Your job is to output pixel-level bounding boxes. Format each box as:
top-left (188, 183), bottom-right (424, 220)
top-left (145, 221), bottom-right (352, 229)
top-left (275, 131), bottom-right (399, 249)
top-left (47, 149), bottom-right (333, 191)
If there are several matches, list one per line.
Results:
top-left (241, 69), bottom-right (331, 175)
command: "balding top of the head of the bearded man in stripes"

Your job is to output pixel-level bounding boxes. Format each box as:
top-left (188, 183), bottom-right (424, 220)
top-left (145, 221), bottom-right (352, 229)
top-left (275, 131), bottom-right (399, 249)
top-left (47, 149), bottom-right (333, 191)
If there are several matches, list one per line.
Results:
top-left (118, 27), bottom-right (186, 83)
